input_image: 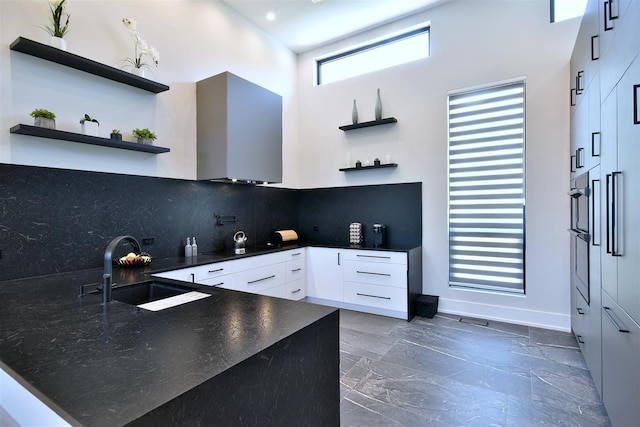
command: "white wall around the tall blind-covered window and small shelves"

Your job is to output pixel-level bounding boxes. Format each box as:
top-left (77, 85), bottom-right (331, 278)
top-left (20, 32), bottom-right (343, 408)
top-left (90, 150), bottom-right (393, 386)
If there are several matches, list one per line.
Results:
top-left (298, 0), bottom-right (579, 330)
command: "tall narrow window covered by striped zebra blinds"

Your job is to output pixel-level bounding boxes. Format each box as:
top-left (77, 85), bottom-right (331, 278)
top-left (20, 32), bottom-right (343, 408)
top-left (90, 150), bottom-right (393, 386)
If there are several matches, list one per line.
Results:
top-left (448, 81), bottom-right (525, 294)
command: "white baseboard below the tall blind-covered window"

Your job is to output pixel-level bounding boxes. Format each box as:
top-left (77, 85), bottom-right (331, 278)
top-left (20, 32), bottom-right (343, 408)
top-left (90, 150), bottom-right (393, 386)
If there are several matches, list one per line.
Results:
top-left (438, 297), bottom-right (571, 332)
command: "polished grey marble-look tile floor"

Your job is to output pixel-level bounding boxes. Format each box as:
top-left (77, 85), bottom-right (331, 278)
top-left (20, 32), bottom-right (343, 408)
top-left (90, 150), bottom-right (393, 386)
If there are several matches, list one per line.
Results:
top-left (340, 310), bottom-right (610, 427)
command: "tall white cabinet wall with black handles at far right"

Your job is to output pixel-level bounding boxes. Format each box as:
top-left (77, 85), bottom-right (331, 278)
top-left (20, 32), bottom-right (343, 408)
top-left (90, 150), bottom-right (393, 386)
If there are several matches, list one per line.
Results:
top-left (571, 0), bottom-right (640, 426)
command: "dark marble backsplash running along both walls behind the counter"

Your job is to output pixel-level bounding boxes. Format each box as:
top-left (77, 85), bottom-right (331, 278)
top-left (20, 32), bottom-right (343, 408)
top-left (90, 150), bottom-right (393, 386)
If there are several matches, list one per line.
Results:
top-left (0, 164), bottom-right (422, 280)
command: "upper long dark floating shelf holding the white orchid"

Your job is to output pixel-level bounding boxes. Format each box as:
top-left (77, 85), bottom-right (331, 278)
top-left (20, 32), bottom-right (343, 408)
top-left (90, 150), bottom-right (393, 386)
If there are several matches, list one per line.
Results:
top-left (11, 37), bottom-right (169, 93)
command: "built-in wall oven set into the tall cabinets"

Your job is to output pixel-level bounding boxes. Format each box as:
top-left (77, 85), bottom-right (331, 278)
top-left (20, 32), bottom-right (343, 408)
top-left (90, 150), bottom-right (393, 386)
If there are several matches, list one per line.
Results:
top-left (568, 172), bottom-right (593, 304)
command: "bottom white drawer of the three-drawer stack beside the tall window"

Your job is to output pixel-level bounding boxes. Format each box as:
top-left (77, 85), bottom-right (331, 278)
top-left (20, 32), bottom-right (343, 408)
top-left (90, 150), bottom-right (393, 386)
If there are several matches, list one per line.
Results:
top-left (344, 282), bottom-right (407, 312)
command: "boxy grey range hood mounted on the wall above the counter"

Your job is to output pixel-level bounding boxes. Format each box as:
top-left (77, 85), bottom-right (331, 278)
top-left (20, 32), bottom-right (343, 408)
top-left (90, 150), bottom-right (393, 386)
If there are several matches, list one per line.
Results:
top-left (196, 72), bottom-right (282, 184)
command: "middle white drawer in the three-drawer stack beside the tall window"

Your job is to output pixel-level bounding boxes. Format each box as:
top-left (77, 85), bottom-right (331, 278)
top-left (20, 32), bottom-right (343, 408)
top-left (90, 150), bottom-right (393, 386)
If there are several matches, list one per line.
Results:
top-left (343, 261), bottom-right (407, 291)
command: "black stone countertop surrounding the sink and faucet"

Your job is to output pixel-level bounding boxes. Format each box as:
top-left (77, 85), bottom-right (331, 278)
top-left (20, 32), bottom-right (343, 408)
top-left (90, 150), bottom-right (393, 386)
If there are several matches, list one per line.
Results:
top-left (0, 247), bottom-right (336, 426)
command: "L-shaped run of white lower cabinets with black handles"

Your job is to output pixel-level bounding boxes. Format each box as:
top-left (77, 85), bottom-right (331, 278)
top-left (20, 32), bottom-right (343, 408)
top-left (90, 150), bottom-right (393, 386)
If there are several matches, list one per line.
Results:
top-left (154, 247), bottom-right (422, 320)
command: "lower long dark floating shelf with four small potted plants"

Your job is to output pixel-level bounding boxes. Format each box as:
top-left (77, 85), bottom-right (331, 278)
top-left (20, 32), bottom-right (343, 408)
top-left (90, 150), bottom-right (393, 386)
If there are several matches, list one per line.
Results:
top-left (10, 124), bottom-right (171, 154)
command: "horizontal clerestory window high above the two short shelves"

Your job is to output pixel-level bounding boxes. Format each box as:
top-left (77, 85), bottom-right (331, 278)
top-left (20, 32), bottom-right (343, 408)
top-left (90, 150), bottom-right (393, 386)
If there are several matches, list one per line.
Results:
top-left (316, 25), bottom-right (429, 85)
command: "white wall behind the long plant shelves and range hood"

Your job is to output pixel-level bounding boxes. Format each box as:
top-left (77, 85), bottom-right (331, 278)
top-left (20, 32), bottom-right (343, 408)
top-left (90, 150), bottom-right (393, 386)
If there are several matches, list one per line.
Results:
top-left (0, 0), bottom-right (297, 182)
